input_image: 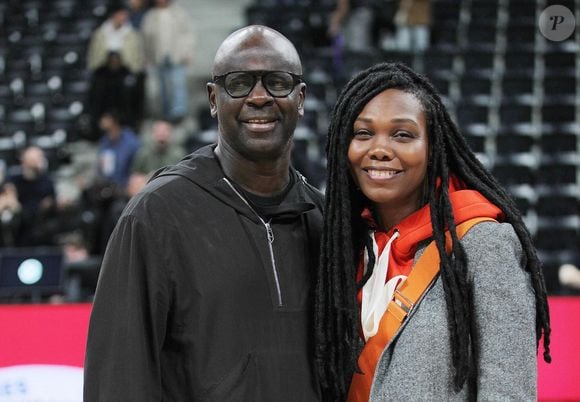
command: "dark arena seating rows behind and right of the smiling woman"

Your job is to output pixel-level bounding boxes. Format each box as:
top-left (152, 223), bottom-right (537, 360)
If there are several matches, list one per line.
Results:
top-left (247, 0), bottom-right (580, 292)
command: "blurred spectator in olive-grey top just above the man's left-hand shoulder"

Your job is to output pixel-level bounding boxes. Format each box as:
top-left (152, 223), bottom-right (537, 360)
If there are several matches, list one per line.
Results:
top-left (133, 120), bottom-right (186, 175)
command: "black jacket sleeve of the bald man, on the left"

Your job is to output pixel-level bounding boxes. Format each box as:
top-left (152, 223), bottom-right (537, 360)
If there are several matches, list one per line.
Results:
top-left (84, 216), bottom-right (170, 402)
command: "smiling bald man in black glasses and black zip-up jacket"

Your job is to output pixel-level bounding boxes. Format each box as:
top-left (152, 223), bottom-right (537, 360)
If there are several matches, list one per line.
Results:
top-left (84, 26), bottom-right (322, 402)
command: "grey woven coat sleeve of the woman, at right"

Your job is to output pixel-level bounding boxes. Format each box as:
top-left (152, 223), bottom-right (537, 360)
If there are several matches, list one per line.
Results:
top-left (464, 223), bottom-right (536, 401)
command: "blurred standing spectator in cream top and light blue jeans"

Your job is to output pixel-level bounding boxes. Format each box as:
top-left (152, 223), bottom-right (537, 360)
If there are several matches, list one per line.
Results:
top-left (141, 0), bottom-right (193, 122)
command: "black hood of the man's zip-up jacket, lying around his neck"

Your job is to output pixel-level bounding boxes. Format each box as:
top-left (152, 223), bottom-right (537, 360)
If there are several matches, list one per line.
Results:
top-left (150, 144), bottom-right (316, 220)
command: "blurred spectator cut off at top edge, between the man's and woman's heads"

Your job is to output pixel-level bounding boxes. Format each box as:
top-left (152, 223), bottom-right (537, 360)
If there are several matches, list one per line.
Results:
top-left (328, 0), bottom-right (374, 51)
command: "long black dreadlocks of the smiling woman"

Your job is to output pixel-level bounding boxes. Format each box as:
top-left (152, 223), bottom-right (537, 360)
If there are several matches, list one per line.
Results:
top-left (315, 63), bottom-right (551, 401)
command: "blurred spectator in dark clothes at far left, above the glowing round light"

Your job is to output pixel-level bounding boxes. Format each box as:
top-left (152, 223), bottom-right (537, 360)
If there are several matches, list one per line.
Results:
top-left (8, 146), bottom-right (57, 246)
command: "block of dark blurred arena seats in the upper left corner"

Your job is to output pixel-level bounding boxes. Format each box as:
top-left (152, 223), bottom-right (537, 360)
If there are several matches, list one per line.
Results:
top-left (0, 0), bottom-right (106, 146)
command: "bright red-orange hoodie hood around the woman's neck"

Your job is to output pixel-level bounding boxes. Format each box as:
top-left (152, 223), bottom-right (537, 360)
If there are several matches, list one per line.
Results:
top-left (357, 177), bottom-right (504, 286)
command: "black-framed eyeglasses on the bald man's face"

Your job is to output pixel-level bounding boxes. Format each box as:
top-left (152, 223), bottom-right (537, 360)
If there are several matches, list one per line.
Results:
top-left (213, 70), bottom-right (302, 98)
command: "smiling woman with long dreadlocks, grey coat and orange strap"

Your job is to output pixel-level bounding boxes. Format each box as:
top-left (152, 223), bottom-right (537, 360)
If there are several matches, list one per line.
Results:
top-left (315, 63), bottom-right (550, 402)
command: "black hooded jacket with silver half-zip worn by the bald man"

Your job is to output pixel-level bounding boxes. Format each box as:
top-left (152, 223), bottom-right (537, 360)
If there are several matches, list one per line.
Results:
top-left (84, 146), bottom-right (323, 402)
